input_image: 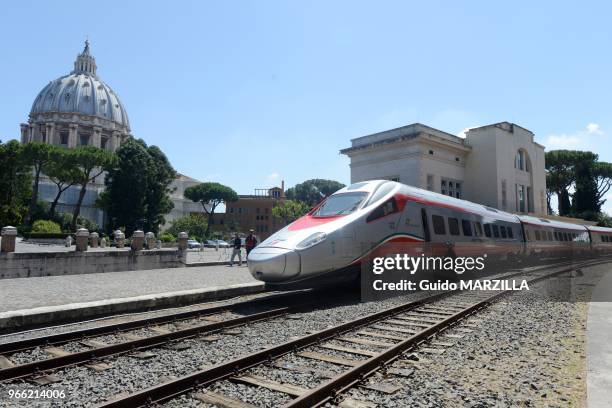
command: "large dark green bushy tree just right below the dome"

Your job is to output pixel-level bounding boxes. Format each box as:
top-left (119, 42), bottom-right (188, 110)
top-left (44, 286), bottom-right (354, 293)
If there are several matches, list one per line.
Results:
top-left (97, 139), bottom-right (176, 234)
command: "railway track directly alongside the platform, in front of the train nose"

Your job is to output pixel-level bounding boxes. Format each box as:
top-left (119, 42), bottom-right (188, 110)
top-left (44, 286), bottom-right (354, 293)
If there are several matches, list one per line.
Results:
top-left (0, 290), bottom-right (352, 381)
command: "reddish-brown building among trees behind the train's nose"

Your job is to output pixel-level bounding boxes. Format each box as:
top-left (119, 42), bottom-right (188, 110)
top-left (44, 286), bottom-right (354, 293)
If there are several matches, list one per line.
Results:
top-left (213, 182), bottom-right (285, 240)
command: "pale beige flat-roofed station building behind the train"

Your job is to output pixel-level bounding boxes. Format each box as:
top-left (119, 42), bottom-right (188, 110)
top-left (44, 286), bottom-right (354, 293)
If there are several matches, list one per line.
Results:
top-left (341, 122), bottom-right (547, 215)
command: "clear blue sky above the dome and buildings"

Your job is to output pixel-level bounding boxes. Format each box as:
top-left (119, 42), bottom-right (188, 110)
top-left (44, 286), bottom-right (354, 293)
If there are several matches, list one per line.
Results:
top-left (0, 1), bottom-right (612, 207)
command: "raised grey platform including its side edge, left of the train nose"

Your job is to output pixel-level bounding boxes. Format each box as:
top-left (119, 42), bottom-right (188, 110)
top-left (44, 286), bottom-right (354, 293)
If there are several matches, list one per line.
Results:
top-left (0, 265), bottom-right (264, 333)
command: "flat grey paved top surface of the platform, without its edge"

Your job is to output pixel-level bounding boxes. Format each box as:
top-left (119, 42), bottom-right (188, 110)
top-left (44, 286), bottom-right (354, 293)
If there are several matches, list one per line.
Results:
top-left (0, 264), bottom-right (258, 313)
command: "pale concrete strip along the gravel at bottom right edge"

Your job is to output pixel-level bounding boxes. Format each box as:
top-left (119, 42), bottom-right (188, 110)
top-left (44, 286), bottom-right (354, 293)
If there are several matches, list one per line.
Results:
top-left (587, 271), bottom-right (612, 408)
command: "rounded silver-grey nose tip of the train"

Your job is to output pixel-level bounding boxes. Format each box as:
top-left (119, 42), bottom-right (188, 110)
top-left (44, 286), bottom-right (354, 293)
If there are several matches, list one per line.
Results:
top-left (248, 247), bottom-right (300, 282)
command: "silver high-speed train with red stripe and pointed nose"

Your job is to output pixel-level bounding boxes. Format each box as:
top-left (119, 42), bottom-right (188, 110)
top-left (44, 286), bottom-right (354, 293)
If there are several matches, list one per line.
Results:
top-left (248, 180), bottom-right (612, 286)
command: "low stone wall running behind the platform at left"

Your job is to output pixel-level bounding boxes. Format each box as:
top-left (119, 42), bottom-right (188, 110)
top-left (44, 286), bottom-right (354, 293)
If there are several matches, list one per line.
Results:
top-left (0, 249), bottom-right (184, 279)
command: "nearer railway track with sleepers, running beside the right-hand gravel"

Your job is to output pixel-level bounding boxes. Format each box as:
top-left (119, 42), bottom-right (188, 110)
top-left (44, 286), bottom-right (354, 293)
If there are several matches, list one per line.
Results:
top-left (87, 259), bottom-right (609, 408)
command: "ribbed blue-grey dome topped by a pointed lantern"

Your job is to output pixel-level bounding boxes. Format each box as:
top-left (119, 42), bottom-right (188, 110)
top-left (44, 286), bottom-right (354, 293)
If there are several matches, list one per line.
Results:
top-left (30, 41), bottom-right (130, 132)
